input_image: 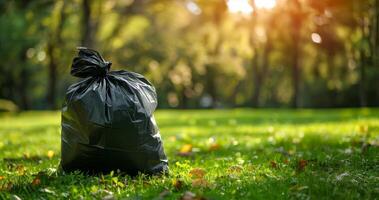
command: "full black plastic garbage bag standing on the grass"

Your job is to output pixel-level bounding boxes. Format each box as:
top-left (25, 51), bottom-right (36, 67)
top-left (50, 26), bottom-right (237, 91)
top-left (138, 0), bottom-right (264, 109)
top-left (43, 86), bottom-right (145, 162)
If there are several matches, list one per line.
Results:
top-left (61, 47), bottom-right (168, 175)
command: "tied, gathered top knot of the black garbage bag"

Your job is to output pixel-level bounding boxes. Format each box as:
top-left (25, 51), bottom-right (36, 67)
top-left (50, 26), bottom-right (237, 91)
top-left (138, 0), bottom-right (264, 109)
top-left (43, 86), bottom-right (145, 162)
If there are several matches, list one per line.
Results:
top-left (71, 47), bottom-right (112, 78)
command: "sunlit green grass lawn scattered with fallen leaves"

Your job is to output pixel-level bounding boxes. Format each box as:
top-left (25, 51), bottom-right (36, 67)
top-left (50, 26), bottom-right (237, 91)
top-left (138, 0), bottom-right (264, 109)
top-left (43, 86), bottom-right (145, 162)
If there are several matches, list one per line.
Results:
top-left (0, 109), bottom-right (379, 199)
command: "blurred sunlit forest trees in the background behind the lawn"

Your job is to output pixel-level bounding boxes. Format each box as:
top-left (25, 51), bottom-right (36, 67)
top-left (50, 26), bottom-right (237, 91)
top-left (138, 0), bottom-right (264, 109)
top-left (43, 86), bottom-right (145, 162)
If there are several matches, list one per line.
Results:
top-left (0, 0), bottom-right (379, 110)
